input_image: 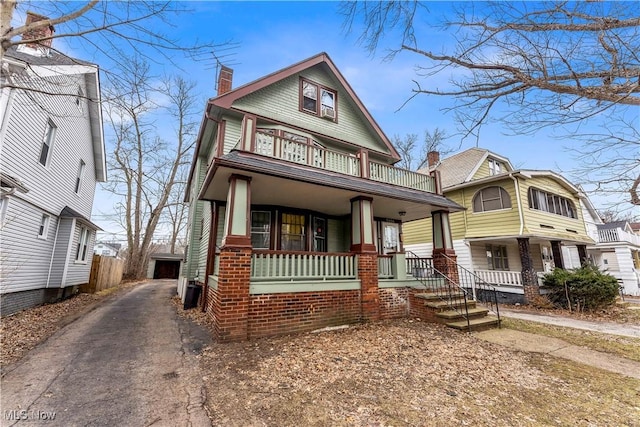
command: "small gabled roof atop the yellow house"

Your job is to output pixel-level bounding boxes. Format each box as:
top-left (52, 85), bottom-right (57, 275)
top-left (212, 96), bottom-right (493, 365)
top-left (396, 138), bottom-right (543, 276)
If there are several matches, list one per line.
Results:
top-left (429, 148), bottom-right (513, 189)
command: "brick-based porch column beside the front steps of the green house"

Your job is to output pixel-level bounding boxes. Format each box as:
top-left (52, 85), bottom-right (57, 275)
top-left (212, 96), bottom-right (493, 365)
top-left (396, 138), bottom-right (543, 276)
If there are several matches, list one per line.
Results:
top-left (431, 211), bottom-right (460, 285)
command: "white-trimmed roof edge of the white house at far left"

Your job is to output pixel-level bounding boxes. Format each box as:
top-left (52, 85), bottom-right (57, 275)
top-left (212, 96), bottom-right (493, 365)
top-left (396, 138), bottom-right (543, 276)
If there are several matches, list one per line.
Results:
top-left (2, 46), bottom-right (107, 182)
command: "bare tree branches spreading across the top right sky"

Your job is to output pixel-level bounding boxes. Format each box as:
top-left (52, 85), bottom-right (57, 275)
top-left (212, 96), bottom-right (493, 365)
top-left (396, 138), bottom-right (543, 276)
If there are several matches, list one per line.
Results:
top-left (342, 1), bottom-right (640, 205)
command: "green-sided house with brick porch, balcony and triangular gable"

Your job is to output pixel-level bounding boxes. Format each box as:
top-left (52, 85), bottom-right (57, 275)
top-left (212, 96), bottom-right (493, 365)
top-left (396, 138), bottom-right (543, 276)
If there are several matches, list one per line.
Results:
top-left (181, 53), bottom-right (470, 340)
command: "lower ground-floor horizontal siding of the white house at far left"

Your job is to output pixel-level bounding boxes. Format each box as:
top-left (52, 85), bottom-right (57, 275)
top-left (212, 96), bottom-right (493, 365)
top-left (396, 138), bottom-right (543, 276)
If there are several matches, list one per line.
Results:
top-left (0, 197), bottom-right (57, 293)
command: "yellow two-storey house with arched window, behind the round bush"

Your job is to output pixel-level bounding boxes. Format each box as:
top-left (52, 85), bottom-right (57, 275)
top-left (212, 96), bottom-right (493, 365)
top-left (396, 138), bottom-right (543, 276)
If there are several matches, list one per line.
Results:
top-left (403, 148), bottom-right (593, 301)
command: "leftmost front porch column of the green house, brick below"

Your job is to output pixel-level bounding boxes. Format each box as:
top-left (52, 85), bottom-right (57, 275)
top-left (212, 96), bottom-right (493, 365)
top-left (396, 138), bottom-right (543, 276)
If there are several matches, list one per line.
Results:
top-left (215, 175), bottom-right (252, 341)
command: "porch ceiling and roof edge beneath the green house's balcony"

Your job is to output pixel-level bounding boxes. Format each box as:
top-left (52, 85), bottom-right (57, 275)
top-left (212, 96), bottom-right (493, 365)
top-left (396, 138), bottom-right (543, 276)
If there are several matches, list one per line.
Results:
top-left (200, 152), bottom-right (461, 221)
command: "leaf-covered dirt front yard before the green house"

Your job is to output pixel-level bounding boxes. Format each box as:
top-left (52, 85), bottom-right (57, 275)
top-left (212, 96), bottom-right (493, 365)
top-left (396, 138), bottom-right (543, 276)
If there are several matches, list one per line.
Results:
top-left (179, 309), bottom-right (640, 426)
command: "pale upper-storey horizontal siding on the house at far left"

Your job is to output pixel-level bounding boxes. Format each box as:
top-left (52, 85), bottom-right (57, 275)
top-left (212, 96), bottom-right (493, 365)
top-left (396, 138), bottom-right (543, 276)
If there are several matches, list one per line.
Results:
top-left (0, 71), bottom-right (96, 218)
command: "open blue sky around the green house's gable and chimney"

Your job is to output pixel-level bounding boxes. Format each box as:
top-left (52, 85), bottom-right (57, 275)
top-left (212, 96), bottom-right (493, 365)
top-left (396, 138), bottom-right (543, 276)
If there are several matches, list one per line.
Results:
top-left (15, 1), bottom-right (636, 241)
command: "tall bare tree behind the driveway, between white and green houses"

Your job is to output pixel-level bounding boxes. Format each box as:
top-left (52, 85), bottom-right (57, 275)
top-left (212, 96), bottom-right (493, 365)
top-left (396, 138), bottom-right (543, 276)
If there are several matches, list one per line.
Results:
top-left (105, 58), bottom-right (195, 278)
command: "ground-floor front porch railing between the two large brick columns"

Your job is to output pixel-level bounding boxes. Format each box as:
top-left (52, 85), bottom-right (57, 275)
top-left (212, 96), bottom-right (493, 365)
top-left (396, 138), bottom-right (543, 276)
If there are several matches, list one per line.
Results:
top-left (251, 251), bottom-right (357, 281)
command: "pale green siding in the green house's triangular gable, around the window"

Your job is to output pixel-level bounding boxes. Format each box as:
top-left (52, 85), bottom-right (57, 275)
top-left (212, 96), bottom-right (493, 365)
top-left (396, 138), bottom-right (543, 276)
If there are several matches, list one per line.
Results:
top-left (234, 65), bottom-right (396, 158)
